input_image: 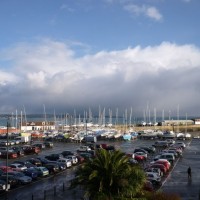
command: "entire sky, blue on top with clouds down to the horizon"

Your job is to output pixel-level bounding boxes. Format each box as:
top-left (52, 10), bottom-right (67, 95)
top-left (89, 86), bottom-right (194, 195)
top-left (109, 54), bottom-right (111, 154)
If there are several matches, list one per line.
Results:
top-left (0, 0), bottom-right (200, 119)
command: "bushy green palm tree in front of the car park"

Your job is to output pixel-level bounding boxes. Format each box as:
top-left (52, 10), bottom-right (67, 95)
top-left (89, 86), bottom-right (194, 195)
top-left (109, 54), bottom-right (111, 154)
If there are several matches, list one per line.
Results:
top-left (71, 149), bottom-right (146, 200)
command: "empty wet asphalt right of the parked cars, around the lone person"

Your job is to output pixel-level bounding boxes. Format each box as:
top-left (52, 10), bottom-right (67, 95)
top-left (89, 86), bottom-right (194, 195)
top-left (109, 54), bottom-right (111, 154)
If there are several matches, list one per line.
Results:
top-left (161, 139), bottom-right (200, 200)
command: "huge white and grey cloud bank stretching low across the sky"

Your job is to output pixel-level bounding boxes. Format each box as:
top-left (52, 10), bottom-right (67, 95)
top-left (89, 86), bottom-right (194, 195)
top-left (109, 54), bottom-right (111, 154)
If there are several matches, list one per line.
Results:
top-left (0, 40), bottom-right (200, 115)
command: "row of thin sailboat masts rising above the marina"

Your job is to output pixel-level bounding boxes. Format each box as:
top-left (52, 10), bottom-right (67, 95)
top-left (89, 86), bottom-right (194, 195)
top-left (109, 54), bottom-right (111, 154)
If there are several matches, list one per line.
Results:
top-left (5, 105), bottom-right (187, 128)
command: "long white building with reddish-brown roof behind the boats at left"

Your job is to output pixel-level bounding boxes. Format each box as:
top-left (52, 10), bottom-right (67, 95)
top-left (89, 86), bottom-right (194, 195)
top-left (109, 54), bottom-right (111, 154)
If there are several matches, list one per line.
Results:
top-left (21, 121), bottom-right (56, 131)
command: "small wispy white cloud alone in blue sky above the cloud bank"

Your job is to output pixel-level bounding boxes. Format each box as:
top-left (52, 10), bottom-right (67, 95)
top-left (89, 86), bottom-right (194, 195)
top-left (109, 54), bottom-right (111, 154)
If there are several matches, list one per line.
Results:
top-left (124, 4), bottom-right (163, 21)
